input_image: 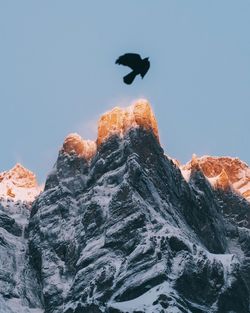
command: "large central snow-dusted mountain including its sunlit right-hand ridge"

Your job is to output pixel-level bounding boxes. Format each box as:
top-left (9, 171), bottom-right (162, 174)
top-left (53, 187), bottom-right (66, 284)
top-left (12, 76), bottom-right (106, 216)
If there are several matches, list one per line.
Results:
top-left (0, 100), bottom-right (250, 313)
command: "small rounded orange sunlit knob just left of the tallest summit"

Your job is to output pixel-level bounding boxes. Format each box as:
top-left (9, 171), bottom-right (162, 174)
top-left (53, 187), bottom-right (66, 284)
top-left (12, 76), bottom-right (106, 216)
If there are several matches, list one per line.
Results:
top-left (63, 133), bottom-right (96, 159)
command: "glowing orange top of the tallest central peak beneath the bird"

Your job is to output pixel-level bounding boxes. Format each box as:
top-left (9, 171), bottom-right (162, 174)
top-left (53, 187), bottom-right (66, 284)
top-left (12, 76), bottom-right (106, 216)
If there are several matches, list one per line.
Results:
top-left (97, 99), bottom-right (159, 145)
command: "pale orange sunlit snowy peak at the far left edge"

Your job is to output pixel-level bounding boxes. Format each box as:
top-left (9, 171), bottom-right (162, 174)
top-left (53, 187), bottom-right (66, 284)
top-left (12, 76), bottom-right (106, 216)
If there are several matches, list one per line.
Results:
top-left (0, 163), bottom-right (41, 202)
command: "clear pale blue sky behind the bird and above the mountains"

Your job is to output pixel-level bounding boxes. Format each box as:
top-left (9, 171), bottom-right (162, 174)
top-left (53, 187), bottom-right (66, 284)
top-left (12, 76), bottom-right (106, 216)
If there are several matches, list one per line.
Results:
top-left (0, 0), bottom-right (250, 182)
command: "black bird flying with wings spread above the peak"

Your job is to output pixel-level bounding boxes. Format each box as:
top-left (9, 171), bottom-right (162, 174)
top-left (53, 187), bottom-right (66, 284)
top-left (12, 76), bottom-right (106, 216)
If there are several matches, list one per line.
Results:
top-left (115, 53), bottom-right (150, 85)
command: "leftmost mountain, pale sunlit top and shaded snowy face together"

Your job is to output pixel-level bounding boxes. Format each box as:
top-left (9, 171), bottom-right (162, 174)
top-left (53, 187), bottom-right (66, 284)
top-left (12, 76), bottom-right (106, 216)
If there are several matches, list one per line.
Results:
top-left (0, 164), bottom-right (42, 313)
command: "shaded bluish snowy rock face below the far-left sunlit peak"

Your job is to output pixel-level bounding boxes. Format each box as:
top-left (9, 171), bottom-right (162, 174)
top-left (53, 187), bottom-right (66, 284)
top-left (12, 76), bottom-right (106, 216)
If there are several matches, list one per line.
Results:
top-left (0, 199), bottom-right (43, 313)
